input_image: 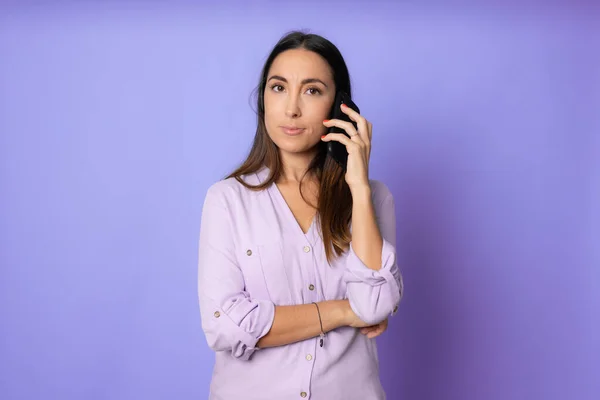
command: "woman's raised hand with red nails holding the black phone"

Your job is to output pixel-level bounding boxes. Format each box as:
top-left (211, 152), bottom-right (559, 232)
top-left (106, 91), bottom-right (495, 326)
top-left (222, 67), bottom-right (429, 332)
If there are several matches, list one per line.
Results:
top-left (321, 104), bottom-right (373, 189)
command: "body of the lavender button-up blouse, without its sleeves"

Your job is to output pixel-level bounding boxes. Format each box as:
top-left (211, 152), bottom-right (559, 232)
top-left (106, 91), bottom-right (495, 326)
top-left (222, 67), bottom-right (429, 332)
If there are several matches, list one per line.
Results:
top-left (210, 170), bottom-right (385, 400)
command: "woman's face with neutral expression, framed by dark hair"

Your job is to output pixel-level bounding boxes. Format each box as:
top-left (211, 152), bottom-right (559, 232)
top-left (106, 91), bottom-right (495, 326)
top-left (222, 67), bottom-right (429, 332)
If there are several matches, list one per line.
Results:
top-left (264, 49), bottom-right (335, 153)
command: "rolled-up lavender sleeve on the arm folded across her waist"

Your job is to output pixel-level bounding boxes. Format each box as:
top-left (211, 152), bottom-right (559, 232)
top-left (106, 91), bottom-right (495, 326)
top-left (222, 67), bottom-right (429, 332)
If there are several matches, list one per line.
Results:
top-left (198, 186), bottom-right (275, 360)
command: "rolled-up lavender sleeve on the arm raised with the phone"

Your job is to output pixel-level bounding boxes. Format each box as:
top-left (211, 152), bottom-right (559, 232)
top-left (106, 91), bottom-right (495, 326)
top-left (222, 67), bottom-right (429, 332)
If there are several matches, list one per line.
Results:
top-left (344, 192), bottom-right (404, 325)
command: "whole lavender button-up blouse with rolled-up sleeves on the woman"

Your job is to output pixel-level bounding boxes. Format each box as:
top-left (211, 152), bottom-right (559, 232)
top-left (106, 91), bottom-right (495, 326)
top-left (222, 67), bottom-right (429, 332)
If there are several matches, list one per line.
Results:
top-left (198, 168), bottom-right (403, 400)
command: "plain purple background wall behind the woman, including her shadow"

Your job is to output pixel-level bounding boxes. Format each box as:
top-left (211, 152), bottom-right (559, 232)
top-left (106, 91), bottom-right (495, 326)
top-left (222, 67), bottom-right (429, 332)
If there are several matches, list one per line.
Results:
top-left (0, 0), bottom-right (600, 400)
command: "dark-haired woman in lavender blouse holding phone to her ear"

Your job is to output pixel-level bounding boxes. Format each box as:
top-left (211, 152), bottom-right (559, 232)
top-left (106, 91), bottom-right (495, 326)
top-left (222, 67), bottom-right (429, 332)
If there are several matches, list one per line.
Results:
top-left (198, 32), bottom-right (403, 400)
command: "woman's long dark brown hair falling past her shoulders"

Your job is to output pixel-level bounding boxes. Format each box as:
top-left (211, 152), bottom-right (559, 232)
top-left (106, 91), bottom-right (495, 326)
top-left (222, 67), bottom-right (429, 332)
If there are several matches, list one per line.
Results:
top-left (226, 31), bottom-right (352, 263)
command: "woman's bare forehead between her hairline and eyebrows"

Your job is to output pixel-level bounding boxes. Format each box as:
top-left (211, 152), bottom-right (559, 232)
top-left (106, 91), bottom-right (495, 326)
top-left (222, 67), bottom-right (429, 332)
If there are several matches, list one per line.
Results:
top-left (269, 49), bottom-right (333, 81)
